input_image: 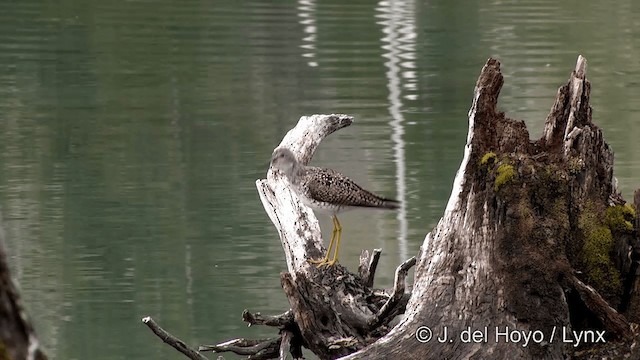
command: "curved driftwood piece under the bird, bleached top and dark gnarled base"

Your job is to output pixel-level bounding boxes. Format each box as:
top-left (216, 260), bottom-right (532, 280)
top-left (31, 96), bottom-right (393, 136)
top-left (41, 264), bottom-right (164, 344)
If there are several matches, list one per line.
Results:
top-left (256, 115), bottom-right (415, 359)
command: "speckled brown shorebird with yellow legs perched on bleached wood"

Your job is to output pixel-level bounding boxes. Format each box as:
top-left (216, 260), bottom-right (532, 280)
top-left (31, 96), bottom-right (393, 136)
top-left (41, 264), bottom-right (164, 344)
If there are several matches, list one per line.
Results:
top-left (271, 148), bottom-right (400, 267)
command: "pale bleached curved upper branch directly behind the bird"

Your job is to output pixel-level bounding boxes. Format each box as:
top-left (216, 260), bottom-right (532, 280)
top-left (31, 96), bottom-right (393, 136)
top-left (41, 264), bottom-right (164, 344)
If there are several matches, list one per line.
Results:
top-left (256, 114), bottom-right (353, 278)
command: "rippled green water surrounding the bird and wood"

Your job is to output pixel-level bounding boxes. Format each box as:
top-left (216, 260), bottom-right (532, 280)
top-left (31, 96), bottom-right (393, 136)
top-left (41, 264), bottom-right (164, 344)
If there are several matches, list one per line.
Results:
top-left (0, 0), bottom-right (640, 360)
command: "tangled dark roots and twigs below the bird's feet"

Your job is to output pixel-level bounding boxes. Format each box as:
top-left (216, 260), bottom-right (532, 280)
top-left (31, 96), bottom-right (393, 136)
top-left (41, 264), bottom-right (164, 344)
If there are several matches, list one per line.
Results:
top-left (142, 249), bottom-right (416, 360)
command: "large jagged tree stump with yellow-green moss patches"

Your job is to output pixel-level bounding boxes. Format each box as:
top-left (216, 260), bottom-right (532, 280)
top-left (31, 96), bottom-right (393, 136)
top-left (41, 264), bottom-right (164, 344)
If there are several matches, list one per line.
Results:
top-left (348, 56), bottom-right (638, 359)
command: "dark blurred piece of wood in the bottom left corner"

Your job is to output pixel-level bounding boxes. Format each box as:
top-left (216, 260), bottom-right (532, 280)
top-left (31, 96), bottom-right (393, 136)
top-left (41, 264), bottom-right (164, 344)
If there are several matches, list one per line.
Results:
top-left (0, 217), bottom-right (47, 360)
